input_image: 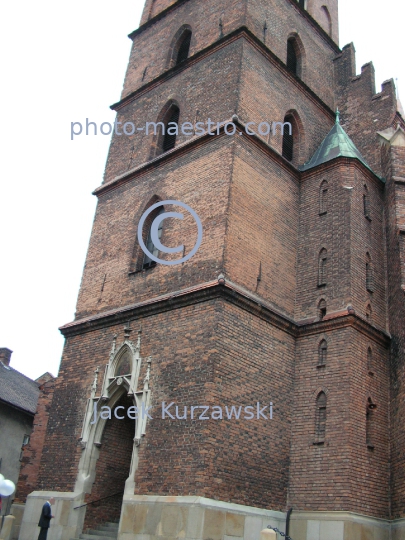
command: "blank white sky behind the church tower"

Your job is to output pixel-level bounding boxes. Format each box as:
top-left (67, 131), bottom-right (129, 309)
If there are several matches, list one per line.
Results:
top-left (0, 0), bottom-right (405, 378)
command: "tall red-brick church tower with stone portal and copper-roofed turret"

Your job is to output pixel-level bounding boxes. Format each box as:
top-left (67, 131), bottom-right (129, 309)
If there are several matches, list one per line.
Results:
top-left (20, 0), bottom-right (405, 540)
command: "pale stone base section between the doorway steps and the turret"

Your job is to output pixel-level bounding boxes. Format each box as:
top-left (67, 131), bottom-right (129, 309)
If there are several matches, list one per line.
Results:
top-left (118, 495), bottom-right (286, 540)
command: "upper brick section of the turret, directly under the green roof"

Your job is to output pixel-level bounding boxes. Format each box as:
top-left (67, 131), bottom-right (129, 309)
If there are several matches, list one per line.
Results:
top-left (296, 161), bottom-right (386, 322)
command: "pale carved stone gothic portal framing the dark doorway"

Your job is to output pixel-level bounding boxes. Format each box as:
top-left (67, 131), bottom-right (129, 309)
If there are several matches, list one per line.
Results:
top-left (74, 331), bottom-right (151, 502)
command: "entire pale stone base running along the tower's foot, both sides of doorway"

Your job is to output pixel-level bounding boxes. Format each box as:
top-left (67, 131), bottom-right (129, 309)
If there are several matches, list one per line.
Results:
top-left (19, 491), bottom-right (405, 540)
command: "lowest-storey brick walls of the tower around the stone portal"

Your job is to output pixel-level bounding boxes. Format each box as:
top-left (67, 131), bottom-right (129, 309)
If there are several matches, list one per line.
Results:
top-left (37, 300), bottom-right (294, 512)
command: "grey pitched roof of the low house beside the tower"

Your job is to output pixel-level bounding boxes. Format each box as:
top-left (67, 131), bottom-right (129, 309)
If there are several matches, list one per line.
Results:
top-left (0, 362), bottom-right (39, 414)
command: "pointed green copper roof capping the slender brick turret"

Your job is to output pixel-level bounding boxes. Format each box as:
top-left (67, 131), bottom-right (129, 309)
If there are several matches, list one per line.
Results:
top-left (300, 111), bottom-right (371, 171)
